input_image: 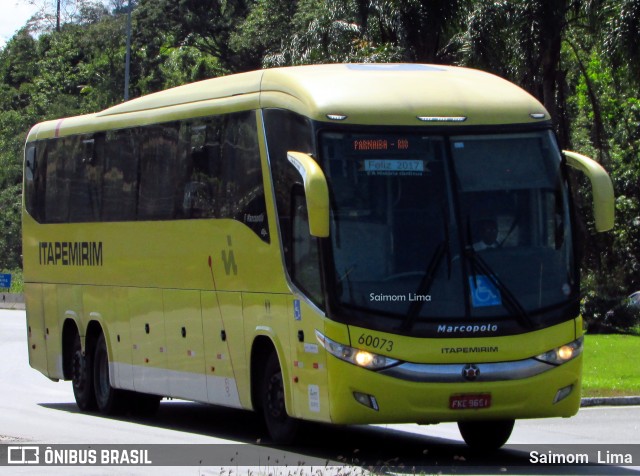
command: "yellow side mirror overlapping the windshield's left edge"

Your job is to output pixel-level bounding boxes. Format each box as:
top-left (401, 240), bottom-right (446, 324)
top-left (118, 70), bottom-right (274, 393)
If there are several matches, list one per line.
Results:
top-left (287, 152), bottom-right (329, 238)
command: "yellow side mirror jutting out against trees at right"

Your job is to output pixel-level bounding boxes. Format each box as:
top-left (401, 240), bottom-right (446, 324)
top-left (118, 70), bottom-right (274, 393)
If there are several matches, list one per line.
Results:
top-left (562, 150), bottom-right (615, 232)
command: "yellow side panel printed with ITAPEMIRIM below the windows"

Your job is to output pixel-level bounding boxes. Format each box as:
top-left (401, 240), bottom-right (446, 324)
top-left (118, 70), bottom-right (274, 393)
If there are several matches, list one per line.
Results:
top-left (23, 213), bottom-right (288, 293)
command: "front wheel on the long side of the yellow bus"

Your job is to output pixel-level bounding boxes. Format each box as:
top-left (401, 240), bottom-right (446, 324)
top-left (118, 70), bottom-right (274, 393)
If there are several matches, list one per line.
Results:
top-left (261, 352), bottom-right (300, 445)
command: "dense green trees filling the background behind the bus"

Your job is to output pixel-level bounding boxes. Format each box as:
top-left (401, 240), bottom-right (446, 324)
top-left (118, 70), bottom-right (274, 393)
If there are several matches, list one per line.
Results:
top-left (0, 0), bottom-right (640, 328)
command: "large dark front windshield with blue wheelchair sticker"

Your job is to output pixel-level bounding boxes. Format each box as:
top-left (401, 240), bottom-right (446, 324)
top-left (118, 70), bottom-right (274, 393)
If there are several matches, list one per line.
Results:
top-left (319, 131), bottom-right (577, 328)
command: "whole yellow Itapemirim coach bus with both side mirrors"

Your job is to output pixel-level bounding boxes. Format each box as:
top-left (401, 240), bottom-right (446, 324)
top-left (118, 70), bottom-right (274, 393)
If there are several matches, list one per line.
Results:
top-left (23, 64), bottom-right (613, 448)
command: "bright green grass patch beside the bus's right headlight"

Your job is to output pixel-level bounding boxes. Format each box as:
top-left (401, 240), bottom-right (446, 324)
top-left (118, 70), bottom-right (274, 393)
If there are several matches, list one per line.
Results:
top-left (582, 334), bottom-right (640, 397)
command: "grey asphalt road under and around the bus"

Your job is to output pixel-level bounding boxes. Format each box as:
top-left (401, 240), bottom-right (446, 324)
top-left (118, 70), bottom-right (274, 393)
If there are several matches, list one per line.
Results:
top-left (0, 310), bottom-right (640, 476)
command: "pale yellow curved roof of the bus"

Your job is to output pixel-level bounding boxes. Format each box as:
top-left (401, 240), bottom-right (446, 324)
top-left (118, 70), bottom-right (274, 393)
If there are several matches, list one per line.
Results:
top-left (29, 64), bottom-right (550, 140)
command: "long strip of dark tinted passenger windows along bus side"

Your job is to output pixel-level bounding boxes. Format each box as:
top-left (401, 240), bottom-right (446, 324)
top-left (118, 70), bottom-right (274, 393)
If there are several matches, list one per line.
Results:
top-left (25, 111), bottom-right (269, 242)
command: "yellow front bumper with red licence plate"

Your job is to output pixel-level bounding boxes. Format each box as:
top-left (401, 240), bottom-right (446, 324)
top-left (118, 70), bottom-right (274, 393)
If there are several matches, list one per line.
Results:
top-left (328, 355), bottom-right (582, 424)
